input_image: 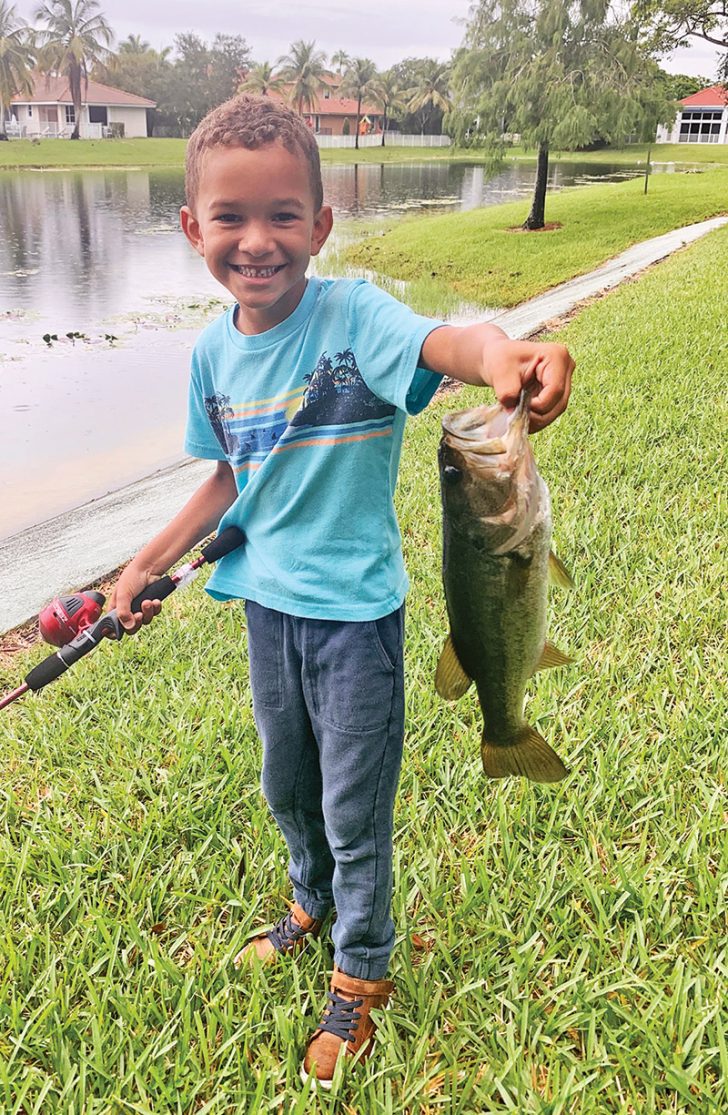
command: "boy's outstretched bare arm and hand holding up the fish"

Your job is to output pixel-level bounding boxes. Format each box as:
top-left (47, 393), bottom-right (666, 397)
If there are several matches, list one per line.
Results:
top-left (421, 323), bottom-right (574, 432)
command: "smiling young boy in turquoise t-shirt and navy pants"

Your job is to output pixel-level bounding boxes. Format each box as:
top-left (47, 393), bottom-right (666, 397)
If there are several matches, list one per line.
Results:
top-left (114, 96), bottom-right (573, 1087)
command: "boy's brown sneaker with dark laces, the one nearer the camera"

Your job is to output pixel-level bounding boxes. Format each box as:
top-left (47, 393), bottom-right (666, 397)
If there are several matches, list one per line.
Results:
top-left (301, 968), bottom-right (394, 1089)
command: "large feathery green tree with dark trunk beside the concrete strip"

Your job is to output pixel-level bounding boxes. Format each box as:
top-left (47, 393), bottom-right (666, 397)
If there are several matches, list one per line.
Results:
top-left (448, 0), bottom-right (674, 229)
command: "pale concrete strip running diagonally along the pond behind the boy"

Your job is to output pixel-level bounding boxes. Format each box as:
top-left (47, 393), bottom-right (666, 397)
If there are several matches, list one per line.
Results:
top-left (0, 217), bottom-right (728, 632)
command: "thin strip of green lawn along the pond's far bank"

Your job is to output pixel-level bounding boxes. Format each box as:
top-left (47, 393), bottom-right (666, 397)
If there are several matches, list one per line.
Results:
top-left (0, 138), bottom-right (728, 169)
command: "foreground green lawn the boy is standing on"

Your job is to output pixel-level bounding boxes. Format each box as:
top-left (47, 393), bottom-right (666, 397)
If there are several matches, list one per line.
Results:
top-left (0, 231), bottom-right (728, 1115)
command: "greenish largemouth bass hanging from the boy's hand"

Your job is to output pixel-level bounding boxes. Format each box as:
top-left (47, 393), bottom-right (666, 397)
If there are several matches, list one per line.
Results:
top-left (435, 391), bottom-right (572, 782)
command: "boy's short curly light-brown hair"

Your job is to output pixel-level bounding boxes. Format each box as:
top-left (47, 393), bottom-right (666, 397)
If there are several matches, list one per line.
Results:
top-left (185, 94), bottom-right (323, 213)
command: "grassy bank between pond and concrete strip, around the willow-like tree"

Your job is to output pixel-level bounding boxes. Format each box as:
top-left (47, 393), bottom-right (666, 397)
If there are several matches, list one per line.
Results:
top-left (346, 169), bottom-right (728, 308)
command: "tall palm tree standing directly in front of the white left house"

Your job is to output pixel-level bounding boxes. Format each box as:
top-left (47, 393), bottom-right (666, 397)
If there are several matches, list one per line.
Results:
top-left (36, 0), bottom-right (114, 139)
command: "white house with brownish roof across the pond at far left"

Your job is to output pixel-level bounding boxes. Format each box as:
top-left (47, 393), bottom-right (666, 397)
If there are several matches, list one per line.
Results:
top-left (7, 74), bottom-right (156, 139)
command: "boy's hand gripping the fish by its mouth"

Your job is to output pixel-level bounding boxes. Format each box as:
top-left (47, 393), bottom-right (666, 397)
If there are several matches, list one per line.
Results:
top-left (483, 337), bottom-right (574, 433)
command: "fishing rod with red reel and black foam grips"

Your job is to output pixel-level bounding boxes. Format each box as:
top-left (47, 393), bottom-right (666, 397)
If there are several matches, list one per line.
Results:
top-left (0, 526), bottom-right (245, 708)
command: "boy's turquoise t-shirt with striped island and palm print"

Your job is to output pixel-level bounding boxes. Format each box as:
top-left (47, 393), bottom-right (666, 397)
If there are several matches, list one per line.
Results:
top-left (185, 270), bottom-right (441, 620)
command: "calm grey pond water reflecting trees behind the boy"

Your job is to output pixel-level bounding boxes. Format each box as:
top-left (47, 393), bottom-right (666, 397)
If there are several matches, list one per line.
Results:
top-left (0, 162), bottom-right (655, 537)
